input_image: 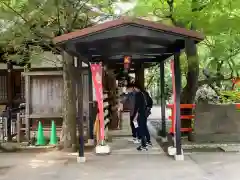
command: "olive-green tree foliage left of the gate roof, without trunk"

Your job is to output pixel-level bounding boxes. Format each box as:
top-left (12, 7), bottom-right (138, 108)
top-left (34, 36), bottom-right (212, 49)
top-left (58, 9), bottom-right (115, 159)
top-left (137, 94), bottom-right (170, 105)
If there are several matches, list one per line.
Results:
top-left (0, 0), bottom-right (116, 62)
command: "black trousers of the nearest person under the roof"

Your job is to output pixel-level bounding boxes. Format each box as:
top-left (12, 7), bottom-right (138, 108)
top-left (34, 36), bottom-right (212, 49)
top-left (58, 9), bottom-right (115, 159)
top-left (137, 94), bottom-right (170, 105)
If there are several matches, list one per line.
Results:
top-left (138, 115), bottom-right (151, 147)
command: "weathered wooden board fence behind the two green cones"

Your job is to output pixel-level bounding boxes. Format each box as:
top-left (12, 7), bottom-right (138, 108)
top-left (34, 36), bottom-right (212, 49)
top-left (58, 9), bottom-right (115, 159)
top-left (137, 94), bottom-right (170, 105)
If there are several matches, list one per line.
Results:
top-left (19, 69), bottom-right (89, 140)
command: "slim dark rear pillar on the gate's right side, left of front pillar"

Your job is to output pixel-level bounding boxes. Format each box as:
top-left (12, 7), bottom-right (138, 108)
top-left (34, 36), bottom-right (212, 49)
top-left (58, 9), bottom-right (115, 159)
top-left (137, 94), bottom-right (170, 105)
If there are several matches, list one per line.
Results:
top-left (160, 61), bottom-right (166, 137)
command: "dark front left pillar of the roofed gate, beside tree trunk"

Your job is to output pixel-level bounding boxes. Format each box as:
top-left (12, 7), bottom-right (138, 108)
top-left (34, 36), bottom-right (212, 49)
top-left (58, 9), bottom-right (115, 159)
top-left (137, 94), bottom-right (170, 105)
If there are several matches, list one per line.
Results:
top-left (77, 58), bottom-right (84, 158)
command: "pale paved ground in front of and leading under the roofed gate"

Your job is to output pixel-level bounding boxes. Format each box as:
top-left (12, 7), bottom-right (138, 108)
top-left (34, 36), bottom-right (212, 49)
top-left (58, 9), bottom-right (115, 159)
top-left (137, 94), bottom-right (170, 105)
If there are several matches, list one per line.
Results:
top-left (0, 105), bottom-right (240, 180)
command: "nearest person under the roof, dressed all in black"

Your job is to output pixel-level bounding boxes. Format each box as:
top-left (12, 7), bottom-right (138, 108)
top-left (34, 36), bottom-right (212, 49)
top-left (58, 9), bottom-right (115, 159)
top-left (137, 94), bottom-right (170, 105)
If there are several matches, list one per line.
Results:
top-left (133, 84), bottom-right (152, 151)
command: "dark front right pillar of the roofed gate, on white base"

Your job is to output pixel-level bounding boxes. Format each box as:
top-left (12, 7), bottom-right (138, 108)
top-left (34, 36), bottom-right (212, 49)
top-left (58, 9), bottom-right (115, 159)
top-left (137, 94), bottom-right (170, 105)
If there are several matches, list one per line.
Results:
top-left (174, 51), bottom-right (182, 155)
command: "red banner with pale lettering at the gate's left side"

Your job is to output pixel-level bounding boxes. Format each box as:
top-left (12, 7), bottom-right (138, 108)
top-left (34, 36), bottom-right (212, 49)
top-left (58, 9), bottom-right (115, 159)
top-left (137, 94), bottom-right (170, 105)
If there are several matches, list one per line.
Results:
top-left (91, 64), bottom-right (104, 141)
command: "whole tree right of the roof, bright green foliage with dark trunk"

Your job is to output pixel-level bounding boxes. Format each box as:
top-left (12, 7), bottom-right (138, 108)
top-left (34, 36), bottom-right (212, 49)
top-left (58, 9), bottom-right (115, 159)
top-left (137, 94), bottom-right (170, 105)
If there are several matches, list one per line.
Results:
top-left (134, 0), bottom-right (240, 103)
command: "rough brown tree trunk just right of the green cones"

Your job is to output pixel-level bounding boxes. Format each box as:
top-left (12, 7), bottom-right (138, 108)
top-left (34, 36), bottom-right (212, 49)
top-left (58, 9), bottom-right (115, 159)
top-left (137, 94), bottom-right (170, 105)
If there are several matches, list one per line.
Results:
top-left (60, 52), bottom-right (77, 151)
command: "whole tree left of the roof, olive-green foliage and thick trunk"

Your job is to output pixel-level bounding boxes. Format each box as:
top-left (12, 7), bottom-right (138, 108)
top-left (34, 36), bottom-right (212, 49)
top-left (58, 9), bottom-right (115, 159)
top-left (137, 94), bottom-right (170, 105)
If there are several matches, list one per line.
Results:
top-left (0, 0), bottom-right (116, 149)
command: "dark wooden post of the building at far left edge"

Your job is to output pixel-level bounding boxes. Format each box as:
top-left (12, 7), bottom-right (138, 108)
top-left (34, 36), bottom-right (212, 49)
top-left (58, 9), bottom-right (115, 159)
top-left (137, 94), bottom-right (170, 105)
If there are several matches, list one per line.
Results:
top-left (7, 62), bottom-right (13, 141)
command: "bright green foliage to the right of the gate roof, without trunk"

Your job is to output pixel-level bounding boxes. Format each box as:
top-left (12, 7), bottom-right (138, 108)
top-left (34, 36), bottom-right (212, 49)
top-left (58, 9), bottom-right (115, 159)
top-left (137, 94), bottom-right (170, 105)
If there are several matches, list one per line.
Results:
top-left (134, 0), bottom-right (240, 101)
